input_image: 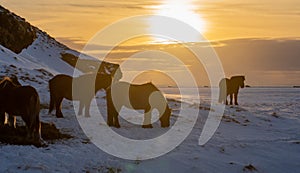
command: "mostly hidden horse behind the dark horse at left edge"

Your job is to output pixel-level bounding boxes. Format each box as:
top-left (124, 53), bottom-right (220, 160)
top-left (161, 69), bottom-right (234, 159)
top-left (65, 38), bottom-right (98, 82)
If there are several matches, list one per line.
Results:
top-left (0, 75), bottom-right (21, 127)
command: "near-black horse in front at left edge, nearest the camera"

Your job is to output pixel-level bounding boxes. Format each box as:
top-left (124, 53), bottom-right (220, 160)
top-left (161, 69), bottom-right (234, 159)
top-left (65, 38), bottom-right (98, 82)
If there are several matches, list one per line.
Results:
top-left (0, 78), bottom-right (41, 140)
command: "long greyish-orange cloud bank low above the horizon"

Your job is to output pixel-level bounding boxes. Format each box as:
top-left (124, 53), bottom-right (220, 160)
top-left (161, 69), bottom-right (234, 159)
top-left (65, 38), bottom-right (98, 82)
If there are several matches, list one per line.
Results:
top-left (58, 37), bottom-right (300, 85)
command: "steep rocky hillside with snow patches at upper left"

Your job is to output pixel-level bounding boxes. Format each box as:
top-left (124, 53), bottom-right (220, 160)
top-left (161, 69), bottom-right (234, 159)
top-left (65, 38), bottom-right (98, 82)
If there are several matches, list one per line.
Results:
top-left (0, 6), bottom-right (122, 79)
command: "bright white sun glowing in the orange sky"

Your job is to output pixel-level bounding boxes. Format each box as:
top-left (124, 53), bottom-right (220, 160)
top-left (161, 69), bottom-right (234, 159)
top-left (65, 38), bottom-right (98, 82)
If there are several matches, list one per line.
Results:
top-left (148, 0), bottom-right (206, 42)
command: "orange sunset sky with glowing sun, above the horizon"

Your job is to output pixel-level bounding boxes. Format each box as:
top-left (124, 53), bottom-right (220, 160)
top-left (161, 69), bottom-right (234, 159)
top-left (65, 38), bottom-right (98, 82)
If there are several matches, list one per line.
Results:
top-left (0, 0), bottom-right (300, 86)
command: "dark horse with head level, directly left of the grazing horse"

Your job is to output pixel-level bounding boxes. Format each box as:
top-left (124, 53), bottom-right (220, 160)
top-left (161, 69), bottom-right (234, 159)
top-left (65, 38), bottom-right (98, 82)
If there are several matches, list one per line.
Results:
top-left (49, 73), bottom-right (112, 118)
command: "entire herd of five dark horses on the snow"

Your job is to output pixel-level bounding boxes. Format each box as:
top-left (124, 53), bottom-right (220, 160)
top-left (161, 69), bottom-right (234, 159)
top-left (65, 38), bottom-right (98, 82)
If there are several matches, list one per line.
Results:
top-left (0, 73), bottom-right (245, 143)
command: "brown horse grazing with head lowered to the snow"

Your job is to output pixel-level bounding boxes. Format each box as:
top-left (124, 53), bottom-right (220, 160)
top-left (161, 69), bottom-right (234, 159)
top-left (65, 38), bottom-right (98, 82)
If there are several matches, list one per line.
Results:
top-left (106, 82), bottom-right (171, 128)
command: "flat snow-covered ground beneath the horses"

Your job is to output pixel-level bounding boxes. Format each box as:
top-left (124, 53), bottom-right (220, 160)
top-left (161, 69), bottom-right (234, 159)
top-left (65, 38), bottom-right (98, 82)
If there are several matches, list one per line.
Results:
top-left (0, 81), bottom-right (300, 173)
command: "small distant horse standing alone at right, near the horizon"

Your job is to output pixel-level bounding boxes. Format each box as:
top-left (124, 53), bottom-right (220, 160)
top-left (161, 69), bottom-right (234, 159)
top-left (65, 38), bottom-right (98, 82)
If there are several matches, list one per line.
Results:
top-left (219, 76), bottom-right (245, 105)
